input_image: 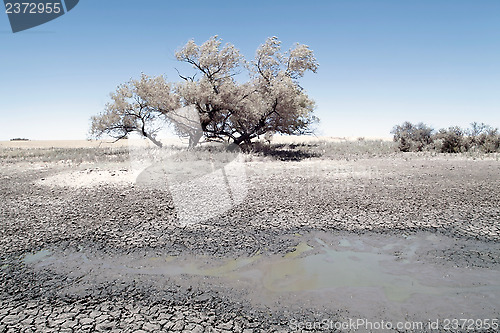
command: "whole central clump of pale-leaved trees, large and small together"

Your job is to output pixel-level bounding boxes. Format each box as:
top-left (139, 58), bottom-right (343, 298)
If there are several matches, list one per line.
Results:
top-left (91, 36), bottom-right (319, 146)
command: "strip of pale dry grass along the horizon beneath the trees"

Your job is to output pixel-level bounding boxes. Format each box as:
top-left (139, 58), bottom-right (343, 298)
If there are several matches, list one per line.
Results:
top-left (0, 137), bottom-right (500, 164)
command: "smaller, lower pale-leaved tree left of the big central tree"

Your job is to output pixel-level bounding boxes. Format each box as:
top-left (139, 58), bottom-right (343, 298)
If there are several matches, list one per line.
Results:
top-left (90, 74), bottom-right (180, 147)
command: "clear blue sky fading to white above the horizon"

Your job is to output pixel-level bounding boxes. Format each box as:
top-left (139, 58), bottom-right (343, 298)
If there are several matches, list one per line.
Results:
top-left (0, 0), bottom-right (500, 140)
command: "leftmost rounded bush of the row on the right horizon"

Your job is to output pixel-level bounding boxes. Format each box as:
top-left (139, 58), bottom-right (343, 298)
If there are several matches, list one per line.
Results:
top-left (391, 121), bottom-right (434, 152)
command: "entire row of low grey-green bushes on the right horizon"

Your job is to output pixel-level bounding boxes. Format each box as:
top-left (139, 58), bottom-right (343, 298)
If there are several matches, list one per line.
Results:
top-left (391, 122), bottom-right (500, 153)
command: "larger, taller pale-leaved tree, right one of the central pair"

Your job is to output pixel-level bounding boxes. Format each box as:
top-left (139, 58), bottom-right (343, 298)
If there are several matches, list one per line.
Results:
top-left (176, 36), bottom-right (318, 145)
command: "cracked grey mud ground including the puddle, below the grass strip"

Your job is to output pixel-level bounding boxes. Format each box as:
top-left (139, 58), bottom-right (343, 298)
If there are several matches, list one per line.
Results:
top-left (0, 143), bottom-right (500, 333)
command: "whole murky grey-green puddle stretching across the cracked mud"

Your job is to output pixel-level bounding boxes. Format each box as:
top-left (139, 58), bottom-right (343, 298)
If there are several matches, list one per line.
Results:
top-left (23, 234), bottom-right (500, 322)
